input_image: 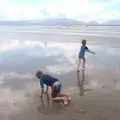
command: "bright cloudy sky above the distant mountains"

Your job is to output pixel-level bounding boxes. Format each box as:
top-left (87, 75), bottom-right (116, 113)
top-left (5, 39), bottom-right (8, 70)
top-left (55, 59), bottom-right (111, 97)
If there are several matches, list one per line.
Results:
top-left (0, 0), bottom-right (120, 22)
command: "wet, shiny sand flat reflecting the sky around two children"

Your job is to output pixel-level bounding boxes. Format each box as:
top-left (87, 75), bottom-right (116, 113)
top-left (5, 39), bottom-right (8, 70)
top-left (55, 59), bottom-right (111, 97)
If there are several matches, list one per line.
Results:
top-left (0, 26), bottom-right (120, 120)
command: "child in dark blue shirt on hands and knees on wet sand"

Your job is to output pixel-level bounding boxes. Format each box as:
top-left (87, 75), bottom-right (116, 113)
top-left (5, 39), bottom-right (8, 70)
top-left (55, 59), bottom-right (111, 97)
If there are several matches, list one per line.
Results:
top-left (36, 71), bottom-right (71, 105)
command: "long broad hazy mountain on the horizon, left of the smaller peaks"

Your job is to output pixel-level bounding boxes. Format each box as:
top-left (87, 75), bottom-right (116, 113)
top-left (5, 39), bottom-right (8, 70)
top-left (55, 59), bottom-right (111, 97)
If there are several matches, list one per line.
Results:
top-left (0, 19), bottom-right (86, 26)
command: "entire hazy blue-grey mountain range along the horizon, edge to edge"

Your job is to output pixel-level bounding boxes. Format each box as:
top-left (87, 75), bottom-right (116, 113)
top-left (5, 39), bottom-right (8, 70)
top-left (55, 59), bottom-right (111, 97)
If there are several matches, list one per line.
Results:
top-left (0, 19), bottom-right (120, 26)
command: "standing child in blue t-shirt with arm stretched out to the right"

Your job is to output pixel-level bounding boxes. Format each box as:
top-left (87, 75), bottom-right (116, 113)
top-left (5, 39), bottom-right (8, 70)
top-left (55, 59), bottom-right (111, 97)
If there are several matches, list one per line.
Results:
top-left (77, 40), bottom-right (95, 72)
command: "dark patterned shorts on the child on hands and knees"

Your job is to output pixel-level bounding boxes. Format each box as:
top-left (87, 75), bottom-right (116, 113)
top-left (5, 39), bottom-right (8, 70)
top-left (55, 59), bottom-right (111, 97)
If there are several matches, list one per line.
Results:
top-left (52, 81), bottom-right (61, 98)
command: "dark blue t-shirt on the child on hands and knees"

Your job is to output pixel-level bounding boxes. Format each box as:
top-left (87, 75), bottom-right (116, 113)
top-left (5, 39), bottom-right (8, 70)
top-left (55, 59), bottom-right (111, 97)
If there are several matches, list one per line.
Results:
top-left (40, 75), bottom-right (58, 88)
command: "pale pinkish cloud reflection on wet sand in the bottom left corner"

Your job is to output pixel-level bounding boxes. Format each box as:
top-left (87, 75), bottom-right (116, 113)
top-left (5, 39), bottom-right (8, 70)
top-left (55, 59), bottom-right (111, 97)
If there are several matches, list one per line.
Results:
top-left (0, 83), bottom-right (36, 119)
